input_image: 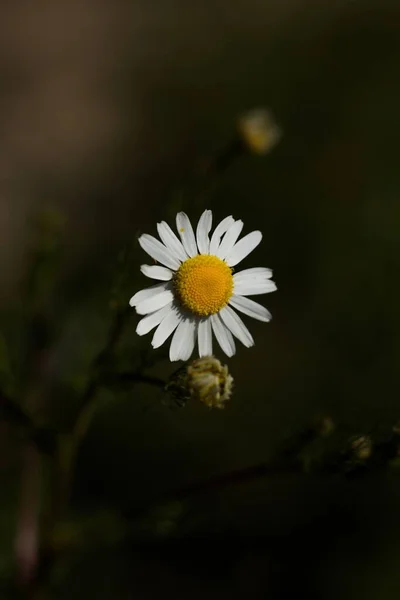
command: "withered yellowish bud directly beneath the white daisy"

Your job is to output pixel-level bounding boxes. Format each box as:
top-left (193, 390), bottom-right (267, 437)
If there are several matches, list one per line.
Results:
top-left (166, 356), bottom-right (233, 408)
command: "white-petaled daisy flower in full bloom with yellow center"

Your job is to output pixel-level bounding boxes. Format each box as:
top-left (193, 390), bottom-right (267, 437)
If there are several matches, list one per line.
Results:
top-left (129, 210), bottom-right (276, 361)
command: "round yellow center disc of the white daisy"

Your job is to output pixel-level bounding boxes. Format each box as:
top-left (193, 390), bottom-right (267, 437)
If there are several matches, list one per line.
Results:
top-left (174, 254), bottom-right (233, 317)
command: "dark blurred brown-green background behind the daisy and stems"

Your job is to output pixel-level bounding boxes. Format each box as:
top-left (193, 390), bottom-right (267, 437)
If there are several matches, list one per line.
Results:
top-left (0, 0), bottom-right (400, 600)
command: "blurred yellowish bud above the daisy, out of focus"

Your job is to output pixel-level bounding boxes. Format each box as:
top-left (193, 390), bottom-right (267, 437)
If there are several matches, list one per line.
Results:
top-left (238, 108), bottom-right (282, 154)
